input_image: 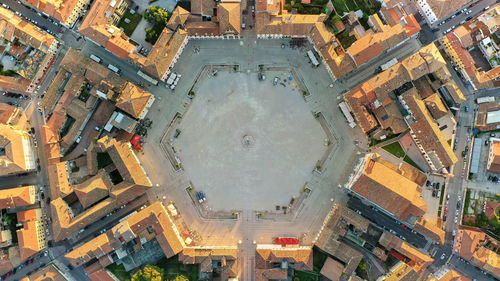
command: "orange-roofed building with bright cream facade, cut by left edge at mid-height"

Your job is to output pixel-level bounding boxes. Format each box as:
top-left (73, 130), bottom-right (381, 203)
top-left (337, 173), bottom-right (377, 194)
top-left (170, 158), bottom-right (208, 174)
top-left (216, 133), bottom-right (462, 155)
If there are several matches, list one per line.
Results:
top-left (0, 124), bottom-right (36, 175)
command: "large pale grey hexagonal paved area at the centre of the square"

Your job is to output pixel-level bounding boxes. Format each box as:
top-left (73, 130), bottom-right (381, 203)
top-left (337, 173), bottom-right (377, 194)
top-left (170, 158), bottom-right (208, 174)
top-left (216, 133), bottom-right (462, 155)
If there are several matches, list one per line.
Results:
top-left (173, 71), bottom-right (326, 210)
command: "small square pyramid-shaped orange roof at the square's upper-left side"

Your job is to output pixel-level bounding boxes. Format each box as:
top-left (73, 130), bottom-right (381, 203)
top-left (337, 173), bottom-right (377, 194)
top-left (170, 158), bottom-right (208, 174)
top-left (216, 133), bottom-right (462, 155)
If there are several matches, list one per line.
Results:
top-left (116, 82), bottom-right (154, 119)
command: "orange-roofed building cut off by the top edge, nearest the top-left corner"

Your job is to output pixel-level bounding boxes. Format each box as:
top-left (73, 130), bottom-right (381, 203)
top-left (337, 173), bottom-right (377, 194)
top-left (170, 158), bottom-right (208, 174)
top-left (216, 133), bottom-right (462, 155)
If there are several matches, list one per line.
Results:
top-left (23, 0), bottom-right (90, 27)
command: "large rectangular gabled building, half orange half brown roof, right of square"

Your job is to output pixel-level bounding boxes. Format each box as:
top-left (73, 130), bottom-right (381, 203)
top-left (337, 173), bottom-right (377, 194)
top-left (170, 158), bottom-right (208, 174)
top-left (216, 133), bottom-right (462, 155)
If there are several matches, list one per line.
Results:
top-left (348, 154), bottom-right (427, 223)
